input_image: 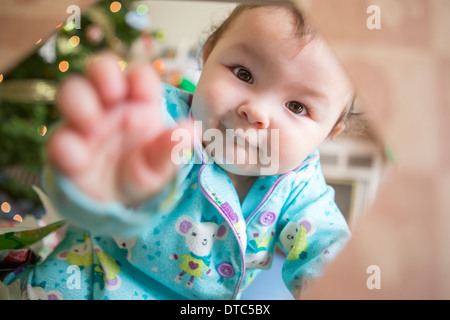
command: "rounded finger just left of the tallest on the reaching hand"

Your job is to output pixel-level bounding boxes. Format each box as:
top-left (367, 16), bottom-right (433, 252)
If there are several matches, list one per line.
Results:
top-left (57, 76), bottom-right (102, 131)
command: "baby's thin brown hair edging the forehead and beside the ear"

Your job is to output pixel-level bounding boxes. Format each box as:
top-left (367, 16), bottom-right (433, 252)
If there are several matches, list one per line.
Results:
top-left (203, 4), bottom-right (359, 136)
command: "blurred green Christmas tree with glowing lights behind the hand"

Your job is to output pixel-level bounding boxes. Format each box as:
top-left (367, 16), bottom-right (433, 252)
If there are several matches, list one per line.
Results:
top-left (0, 0), bottom-right (158, 220)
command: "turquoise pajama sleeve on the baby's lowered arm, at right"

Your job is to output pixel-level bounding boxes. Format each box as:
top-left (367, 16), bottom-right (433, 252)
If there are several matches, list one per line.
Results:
top-left (278, 161), bottom-right (350, 296)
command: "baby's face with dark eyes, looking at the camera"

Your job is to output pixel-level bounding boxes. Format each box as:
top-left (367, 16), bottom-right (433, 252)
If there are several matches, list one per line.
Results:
top-left (192, 8), bottom-right (352, 176)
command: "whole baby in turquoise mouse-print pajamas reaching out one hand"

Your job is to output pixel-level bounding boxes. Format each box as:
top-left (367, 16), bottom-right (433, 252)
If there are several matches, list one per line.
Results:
top-left (11, 6), bottom-right (353, 299)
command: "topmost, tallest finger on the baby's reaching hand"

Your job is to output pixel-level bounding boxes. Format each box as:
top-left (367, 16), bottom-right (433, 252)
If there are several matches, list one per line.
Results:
top-left (86, 53), bottom-right (127, 107)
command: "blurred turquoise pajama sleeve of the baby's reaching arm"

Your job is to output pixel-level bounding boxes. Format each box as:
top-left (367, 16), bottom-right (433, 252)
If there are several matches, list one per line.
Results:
top-left (42, 85), bottom-right (195, 238)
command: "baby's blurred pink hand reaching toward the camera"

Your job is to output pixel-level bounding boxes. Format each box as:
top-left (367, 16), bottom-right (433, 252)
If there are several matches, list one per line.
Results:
top-left (47, 54), bottom-right (193, 206)
